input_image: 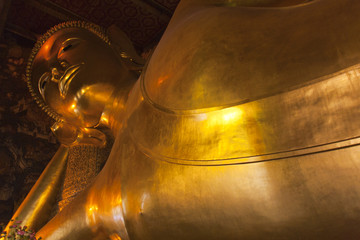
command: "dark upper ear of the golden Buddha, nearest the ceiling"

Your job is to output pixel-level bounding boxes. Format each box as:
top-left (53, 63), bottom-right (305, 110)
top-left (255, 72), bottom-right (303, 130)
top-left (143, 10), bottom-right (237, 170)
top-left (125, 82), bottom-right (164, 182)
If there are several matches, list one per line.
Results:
top-left (107, 25), bottom-right (145, 71)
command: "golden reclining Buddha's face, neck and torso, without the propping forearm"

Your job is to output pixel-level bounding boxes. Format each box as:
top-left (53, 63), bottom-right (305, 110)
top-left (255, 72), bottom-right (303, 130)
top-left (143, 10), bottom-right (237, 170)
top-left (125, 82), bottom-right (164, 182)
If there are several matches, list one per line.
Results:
top-left (7, 0), bottom-right (360, 240)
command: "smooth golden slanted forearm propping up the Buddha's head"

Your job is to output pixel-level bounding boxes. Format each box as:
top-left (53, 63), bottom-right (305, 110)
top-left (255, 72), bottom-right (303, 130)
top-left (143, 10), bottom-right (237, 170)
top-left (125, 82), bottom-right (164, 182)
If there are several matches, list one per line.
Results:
top-left (6, 145), bottom-right (69, 231)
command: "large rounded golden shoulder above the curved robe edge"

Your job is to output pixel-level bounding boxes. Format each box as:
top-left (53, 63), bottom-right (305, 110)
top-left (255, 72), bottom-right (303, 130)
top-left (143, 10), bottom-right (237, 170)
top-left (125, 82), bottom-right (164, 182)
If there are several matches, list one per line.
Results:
top-left (144, 1), bottom-right (360, 109)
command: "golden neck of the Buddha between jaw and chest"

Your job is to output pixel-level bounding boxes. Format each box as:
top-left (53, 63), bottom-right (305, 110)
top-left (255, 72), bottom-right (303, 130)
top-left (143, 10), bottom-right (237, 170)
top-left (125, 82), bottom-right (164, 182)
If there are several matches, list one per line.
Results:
top-left (100, 74), bottom-right (137, 138)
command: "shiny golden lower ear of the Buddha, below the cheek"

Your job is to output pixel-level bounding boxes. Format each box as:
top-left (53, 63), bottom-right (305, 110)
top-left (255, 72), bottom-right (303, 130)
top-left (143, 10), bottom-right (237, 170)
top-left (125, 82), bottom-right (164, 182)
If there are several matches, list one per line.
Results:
top-left (51, 122), bottom-right (106, 147)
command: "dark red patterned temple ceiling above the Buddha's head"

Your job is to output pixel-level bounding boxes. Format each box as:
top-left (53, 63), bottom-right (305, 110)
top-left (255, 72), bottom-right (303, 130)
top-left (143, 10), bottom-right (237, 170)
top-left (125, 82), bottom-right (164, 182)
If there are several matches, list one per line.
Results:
top-left (5, 0), bottom-right (179, 51)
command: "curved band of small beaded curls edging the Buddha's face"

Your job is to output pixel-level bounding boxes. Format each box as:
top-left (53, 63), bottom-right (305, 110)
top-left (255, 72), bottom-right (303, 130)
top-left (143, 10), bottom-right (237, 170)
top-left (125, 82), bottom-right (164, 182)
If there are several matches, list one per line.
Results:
top-left (24, 21), bottom-right (111, 122)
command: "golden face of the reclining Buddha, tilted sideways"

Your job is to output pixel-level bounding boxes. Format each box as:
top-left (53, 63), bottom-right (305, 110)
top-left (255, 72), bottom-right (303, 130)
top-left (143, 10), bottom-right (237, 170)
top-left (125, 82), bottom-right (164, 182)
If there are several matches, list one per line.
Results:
top-left (32, 28), bottom-right (127, 127)
